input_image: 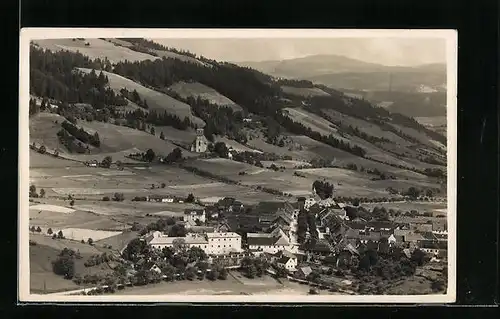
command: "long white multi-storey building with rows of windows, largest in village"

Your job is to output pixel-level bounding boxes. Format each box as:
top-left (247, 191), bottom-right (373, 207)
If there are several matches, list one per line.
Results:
top-left (146, 231), bottom-right (242, 255)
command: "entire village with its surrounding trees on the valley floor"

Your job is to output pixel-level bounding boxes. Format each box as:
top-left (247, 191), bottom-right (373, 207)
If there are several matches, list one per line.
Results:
top-left (34, 189), bottom-right (447, 294)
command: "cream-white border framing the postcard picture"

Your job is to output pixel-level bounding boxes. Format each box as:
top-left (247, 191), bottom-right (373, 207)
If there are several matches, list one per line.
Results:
top-left (18, 28), bottom-right (458, 304)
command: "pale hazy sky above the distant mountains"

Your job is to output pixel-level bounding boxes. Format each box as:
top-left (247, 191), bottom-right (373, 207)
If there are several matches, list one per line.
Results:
top-left (152, 38), bottom-right (446, 66)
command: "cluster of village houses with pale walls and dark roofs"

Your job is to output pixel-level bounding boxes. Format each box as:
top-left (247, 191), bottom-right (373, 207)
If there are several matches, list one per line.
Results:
top-left (138, 198), bottom-right (447, 272)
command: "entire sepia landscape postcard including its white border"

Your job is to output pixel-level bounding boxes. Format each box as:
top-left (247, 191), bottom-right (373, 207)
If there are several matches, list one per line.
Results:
top-left (18, 28), bottom-right (457, 303)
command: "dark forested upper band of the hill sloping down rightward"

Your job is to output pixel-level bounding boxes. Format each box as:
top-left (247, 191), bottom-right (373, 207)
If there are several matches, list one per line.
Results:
top-left (30, 39), bottom-right (446, 179)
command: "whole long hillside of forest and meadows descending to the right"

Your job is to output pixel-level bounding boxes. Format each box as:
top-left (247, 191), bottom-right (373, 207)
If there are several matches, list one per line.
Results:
top-left (30, 39), bottom-right (446, 200)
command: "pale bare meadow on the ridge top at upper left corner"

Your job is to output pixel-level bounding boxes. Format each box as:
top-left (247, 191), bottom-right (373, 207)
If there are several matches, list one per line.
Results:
top-left (33, 39), bottom-right (158, 63)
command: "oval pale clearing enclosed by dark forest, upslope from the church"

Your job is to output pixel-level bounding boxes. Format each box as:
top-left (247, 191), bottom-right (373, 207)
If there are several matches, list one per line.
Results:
top-left (169, 82), bottom-right (242, 112)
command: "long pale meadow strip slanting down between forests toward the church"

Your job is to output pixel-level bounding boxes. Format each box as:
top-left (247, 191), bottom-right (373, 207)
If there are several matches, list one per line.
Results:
top-left (79, 68), bottom-right (205, 126)
